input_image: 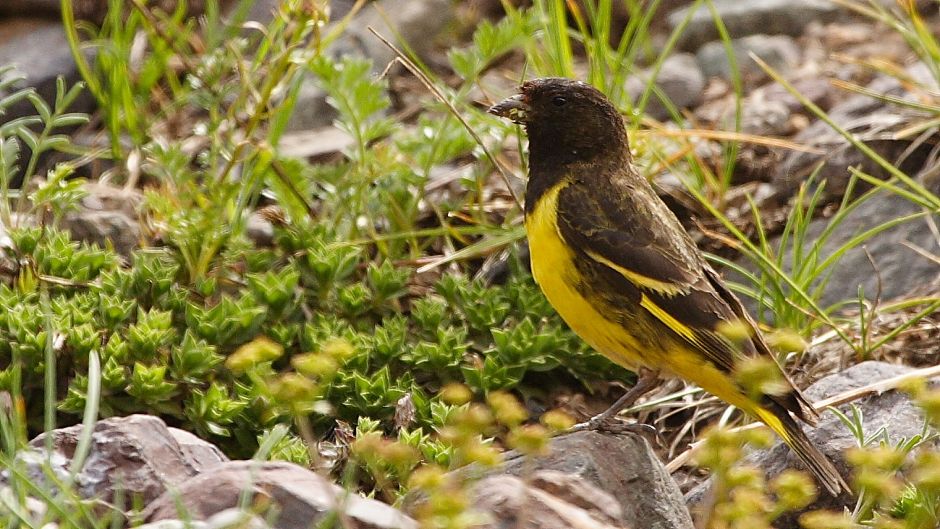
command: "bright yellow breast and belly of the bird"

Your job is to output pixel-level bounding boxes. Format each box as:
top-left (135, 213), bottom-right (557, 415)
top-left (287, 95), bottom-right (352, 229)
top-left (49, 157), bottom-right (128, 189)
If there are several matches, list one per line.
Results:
top-left (525, 181), bottom-right (648, 369)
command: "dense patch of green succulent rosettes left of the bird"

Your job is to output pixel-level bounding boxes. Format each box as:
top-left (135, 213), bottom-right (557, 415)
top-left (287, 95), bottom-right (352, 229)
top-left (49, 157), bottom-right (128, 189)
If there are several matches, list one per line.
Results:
top-left (0, 219), bottom-right (626, 456)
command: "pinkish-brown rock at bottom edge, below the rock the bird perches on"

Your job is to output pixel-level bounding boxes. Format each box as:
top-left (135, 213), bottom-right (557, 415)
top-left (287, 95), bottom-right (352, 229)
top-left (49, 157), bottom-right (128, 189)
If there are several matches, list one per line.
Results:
top-left (473, 471), bottom-right (623, 529)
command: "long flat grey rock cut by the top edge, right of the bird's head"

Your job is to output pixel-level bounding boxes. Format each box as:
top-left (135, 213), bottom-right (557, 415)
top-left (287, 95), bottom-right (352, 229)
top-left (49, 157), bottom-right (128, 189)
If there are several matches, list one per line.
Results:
top-left (669, 0), bottom-right (839, 50)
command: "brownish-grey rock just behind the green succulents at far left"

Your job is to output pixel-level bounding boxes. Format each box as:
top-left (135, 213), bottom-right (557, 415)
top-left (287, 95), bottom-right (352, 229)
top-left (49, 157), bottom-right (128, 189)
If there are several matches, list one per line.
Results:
top-left (62, 182), bottom-right (143, 257)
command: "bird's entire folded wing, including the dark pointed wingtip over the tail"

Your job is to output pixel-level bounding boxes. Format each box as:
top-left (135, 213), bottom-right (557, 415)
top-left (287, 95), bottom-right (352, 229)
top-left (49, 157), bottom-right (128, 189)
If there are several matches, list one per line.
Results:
top-left (558, 179), bottom-right (818, 424)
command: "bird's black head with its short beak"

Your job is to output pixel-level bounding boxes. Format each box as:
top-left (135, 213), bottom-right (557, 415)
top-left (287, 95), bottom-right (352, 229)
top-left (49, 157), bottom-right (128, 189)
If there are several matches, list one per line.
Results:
top-left (489, 77), bottom-right (629, 169)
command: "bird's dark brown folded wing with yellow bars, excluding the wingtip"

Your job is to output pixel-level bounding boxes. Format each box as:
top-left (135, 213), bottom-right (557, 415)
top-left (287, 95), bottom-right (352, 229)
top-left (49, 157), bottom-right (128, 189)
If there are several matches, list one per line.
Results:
top-left (558, 179), bottom-right (749, 372)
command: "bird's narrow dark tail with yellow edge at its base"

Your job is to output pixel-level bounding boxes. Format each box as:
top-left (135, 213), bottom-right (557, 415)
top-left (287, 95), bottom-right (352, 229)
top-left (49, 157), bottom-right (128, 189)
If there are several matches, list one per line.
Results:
top-left (754, 402), bottom-right (851, 497)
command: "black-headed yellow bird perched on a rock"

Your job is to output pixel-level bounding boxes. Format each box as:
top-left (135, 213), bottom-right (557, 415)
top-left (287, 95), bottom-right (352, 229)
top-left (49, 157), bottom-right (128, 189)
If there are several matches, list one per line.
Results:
top-left (489, 77), bottom-right (850, 496)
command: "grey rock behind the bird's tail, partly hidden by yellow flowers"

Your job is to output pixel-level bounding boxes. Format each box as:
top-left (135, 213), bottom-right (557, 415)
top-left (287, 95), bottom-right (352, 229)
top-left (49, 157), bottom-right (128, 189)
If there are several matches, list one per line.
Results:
top-left (686, 361), bottom-right (940, 527)
